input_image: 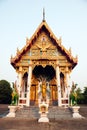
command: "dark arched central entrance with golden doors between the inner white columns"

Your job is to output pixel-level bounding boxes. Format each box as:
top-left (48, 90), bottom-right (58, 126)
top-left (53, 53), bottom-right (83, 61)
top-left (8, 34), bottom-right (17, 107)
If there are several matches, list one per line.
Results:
top-left (30, 65), bottom-right (58, 105)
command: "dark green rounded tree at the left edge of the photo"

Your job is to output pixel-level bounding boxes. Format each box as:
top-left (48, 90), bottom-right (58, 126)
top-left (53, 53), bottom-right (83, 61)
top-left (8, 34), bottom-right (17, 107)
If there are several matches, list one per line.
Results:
top-left (0, 80), bottom-right (12, 104)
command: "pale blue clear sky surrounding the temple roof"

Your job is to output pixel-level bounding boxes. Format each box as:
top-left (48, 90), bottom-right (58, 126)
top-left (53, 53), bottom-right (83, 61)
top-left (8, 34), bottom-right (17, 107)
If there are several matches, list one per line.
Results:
top-left (0, 0), bottom-right (87, 88)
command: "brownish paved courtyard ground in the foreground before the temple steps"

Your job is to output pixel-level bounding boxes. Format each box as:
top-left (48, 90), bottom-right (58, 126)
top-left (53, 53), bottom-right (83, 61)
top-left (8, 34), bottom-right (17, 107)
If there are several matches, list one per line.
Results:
top-left (0, 106), bottom-right (87, 130)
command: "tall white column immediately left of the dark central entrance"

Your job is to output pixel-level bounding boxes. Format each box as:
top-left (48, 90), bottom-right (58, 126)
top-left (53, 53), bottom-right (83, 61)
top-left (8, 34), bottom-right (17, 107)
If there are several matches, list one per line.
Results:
top-left (26, 61), bottom-right (32, 106)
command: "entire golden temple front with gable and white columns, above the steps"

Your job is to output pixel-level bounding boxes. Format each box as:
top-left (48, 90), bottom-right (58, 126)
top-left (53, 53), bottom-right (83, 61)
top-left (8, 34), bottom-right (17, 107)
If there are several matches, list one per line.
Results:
top-left (10, 20), bottom-right (77, 106)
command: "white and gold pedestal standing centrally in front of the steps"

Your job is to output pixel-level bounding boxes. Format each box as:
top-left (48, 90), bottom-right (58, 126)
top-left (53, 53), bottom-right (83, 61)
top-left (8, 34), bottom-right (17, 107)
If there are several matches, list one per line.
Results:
top-left (38, 101), bottom-right (49, 122)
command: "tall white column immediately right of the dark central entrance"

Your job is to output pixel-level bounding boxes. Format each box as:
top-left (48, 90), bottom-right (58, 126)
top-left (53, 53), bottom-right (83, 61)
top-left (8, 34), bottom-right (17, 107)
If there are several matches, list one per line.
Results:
top-left (56, 63), bottom-right (61, 106)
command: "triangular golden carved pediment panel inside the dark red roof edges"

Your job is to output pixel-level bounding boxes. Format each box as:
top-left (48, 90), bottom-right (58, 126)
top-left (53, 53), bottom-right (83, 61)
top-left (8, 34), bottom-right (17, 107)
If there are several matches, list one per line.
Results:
top-left (28, 32), bottom-right (58, 57)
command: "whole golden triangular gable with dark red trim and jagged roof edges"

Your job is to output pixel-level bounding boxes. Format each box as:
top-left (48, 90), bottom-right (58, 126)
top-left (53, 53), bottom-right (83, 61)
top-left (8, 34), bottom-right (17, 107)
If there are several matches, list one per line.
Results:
top-left (11, 21), bottom-right (77, 68)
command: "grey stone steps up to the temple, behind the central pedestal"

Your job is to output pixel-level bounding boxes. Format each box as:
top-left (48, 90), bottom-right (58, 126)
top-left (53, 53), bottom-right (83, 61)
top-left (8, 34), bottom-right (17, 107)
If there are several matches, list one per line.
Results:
top-left (16, 106), bottom-right (72, 120)
